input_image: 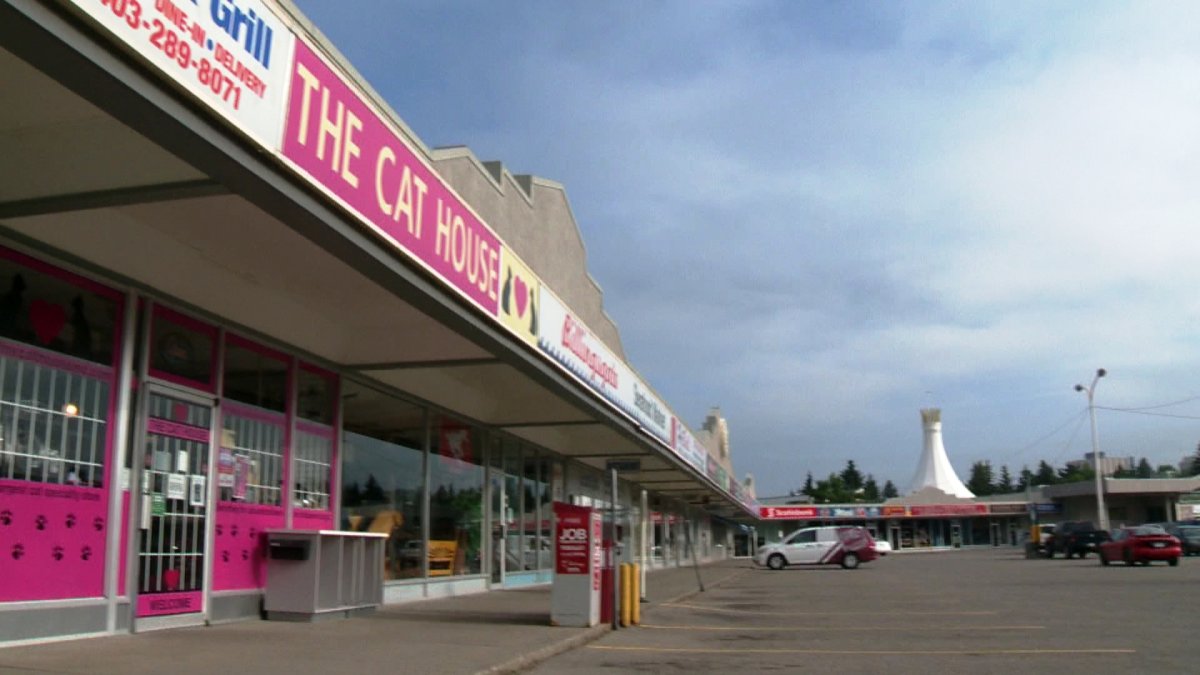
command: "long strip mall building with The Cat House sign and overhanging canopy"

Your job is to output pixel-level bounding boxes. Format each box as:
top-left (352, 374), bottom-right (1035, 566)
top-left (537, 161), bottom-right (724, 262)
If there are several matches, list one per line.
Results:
top-left (0, 0), bottom-right (757, 641)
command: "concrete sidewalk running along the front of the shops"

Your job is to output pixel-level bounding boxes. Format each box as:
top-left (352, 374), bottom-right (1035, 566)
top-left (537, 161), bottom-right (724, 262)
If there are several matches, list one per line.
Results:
top-left (0, 560), bottom-right (752, 675)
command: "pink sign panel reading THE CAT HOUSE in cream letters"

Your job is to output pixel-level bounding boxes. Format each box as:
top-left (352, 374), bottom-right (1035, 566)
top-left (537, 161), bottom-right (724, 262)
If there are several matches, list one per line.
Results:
top-left (282, 41), bottom-right (500, 316)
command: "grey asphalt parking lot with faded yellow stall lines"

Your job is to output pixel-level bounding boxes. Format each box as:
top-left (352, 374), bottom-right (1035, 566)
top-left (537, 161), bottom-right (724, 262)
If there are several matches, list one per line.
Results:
top-left (530, 548), bottom-right (1200, 675)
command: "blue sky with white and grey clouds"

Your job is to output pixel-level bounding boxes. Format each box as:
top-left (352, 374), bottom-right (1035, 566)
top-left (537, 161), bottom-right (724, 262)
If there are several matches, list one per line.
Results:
top-left (296, 0), bottom-right (1200, 496)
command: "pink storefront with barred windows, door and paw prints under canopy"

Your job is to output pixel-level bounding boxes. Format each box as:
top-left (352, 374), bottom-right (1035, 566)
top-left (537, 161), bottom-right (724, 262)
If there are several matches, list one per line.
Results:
top-left (0, 242), bottom-right (337, 628)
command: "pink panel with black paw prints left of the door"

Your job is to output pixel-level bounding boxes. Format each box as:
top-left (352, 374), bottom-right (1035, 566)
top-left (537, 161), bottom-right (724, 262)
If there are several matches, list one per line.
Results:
top-left (0, 480), bottom-right (108, 602)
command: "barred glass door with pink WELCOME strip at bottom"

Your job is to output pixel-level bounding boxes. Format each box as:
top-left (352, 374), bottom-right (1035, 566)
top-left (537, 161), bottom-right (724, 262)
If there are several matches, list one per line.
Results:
top-left (137, 386), bottom-right (214, 619)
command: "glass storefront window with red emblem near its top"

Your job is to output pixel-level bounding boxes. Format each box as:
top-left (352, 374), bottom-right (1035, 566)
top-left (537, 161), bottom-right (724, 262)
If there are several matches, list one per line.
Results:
top-left (428, 416), bottom-right (484, 577)
